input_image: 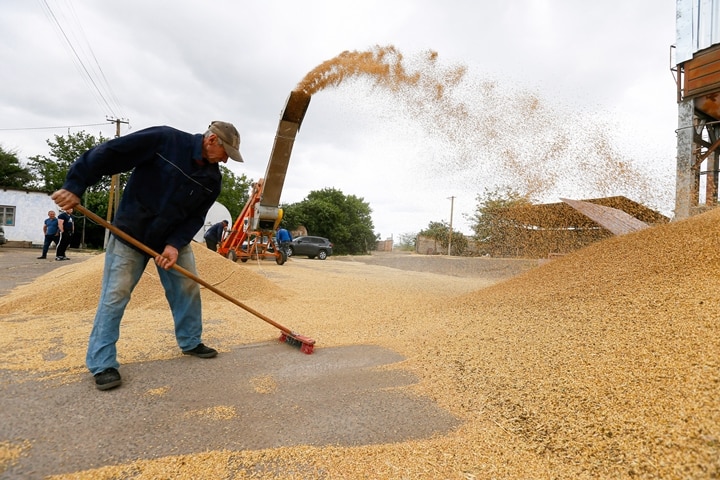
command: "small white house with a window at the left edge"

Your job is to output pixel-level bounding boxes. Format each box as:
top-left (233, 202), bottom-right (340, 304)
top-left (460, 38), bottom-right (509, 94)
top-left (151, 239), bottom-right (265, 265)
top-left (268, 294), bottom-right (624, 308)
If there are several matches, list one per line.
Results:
top-left (0, 187), bottom-right (60, 245)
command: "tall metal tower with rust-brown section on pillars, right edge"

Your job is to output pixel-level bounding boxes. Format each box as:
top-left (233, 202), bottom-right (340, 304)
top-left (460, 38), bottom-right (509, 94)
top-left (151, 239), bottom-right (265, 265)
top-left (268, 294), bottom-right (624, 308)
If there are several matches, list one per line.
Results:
top-left (673, 0), bottom-right (720, 219)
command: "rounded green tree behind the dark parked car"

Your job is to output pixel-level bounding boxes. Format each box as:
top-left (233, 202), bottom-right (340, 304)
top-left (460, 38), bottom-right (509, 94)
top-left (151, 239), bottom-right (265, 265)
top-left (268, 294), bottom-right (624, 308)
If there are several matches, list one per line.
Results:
top-left (283, 188), bottom-right (378, 255)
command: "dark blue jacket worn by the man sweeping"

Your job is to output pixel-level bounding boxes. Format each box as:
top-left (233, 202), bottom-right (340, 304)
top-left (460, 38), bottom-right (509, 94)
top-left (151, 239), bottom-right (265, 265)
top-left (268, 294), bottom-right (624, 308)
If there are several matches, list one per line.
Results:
top-left (63, 127), bottom-right (221, 253)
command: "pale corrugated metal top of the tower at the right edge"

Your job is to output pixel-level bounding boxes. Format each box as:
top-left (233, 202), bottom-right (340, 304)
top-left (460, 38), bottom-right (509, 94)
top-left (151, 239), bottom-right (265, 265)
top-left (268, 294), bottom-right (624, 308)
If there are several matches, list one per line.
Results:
top-left (675, 0), bottom-right (720, 64)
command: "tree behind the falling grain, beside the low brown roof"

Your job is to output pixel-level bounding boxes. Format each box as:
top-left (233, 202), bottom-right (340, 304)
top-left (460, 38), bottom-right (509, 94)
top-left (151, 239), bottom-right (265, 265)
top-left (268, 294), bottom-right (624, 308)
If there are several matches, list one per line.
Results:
top-left (471, 188), bottom-right (532, 256)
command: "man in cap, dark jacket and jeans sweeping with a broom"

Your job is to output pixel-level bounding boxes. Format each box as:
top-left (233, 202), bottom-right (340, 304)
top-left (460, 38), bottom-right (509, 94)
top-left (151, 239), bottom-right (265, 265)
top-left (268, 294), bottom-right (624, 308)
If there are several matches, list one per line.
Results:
top-left (52, 121), bottom-right (243, 390)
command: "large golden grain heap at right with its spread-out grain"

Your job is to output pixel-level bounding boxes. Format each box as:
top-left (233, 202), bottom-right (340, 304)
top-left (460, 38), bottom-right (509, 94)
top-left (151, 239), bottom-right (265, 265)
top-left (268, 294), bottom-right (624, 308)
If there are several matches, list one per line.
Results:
top-left (0, 209), bottom-right (720, 479)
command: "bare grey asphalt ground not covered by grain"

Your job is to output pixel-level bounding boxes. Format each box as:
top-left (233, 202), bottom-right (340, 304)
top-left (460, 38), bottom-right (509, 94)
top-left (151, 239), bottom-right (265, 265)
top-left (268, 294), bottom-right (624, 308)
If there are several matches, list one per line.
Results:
top-left (0, 247), bottom-right (478, 479)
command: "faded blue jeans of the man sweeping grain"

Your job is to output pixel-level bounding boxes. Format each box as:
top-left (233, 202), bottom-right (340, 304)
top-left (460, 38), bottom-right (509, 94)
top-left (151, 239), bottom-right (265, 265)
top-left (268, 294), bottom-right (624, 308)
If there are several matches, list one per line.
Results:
top-left (85, 235), bottom-right (202, 375)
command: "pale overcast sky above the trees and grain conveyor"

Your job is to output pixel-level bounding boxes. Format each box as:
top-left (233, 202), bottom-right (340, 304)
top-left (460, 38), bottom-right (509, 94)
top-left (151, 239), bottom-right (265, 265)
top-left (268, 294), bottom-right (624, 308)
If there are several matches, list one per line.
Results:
top-left (0, 0), bottom-right (677, 238)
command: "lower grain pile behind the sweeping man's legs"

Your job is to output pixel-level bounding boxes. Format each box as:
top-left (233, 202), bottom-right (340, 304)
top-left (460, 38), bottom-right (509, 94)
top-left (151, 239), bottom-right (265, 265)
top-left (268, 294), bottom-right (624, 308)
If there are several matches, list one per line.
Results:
top-left (0, 243), bottom-right (283, 375)
